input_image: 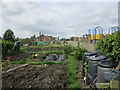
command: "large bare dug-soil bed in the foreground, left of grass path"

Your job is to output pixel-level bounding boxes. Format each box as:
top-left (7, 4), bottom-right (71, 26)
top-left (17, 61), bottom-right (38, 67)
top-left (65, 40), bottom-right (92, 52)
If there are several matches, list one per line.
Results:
top-left (2, 64), bottom-right (67, 88)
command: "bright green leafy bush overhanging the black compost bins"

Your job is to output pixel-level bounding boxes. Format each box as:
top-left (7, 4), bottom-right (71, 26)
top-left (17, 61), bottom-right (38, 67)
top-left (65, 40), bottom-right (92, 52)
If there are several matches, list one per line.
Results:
top-left (97, 31), bottom-right (120, 61)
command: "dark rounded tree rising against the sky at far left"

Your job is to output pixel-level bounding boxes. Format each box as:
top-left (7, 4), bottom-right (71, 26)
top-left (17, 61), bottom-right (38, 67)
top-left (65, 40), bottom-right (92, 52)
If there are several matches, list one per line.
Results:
top-left (3, 29), bottom-right (15, 42)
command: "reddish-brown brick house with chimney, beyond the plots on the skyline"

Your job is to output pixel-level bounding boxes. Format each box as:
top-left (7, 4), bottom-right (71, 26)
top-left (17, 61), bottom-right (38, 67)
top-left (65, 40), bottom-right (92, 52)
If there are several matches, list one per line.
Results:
top-left (36, 33), bottom-right (55, 43)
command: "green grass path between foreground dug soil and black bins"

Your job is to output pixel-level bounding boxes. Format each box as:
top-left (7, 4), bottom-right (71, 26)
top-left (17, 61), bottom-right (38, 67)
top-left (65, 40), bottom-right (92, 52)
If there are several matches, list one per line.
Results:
top-left (67, 56), bottom-right (81, 88)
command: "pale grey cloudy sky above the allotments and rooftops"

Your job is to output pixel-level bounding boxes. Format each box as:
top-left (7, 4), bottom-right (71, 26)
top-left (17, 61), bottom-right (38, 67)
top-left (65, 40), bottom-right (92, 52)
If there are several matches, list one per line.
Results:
top-left (0, 2), bottom-right (118, 38)
